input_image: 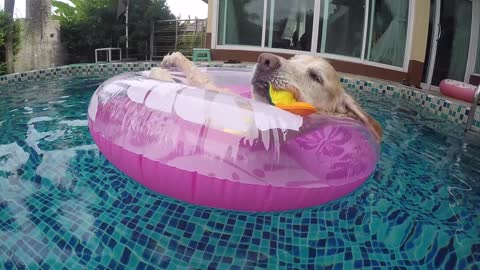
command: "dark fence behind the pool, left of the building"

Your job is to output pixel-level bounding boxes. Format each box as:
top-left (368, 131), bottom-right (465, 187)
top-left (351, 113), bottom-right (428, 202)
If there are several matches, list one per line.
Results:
top-left (150, 19), bottom-right (207, 60)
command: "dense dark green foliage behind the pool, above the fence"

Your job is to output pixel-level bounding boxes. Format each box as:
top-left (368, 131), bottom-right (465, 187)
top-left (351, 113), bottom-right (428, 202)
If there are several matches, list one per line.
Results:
top-left (52, 0), bottom-right (174, 60)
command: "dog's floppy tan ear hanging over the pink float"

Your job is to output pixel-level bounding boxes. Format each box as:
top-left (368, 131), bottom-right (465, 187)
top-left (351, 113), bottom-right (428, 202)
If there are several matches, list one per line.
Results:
top-left (341, 94), bottom-right (382, 142)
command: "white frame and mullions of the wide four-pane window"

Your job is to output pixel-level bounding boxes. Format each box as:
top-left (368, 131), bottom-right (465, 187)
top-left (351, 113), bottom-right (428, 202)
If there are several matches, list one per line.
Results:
top-left (210, 0), bottom-right (417, 72)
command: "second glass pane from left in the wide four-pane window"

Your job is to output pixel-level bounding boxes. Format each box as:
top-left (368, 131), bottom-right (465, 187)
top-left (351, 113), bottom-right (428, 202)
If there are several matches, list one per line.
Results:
top-left (265, 0), bottom-right (315, 51)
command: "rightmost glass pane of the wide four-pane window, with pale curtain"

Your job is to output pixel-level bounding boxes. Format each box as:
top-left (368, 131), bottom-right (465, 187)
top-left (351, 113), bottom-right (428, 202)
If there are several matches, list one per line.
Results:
top-left (366, 0), bottom-right (408, 67)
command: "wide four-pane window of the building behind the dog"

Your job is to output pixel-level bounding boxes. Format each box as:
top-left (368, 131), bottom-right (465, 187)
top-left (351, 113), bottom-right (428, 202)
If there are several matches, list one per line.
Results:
top-left (216, 0), bottom-right (412, 68)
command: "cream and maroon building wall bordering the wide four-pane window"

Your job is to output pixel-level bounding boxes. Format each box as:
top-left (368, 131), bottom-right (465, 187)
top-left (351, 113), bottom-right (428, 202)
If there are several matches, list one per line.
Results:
top-left (207, 0), bottom-right (430, 87)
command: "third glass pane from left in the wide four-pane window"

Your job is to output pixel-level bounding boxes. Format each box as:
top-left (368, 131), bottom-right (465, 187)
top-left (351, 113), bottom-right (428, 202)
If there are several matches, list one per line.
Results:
top-left (317, 0), bottom-right (366, 58)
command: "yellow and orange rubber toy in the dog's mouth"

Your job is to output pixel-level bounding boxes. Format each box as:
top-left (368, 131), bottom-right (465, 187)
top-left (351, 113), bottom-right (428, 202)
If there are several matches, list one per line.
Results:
top-left (267, 84), bottom-right (317, 116)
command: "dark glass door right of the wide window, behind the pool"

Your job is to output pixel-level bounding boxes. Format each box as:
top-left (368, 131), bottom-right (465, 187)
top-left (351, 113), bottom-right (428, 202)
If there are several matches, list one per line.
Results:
top-left (425, 0), bottom-right (477, 88)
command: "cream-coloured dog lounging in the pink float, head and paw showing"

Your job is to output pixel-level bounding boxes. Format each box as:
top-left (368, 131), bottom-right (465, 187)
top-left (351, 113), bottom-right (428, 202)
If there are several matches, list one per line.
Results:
top-left (150, 52), bottom-right (382, 142)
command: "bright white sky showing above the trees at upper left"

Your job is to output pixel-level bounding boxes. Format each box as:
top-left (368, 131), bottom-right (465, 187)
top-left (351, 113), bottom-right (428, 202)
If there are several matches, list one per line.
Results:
top-left (0, 0), bottom-right (208, 19)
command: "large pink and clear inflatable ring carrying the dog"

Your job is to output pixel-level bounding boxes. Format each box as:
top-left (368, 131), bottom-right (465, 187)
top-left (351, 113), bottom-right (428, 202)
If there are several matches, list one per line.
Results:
top-left (88, 68), bottom-right (379, 212)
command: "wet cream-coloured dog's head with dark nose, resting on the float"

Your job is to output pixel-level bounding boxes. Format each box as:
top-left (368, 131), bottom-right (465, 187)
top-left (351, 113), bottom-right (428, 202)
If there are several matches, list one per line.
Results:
top-left (252, 53), bottom-right (382, 141)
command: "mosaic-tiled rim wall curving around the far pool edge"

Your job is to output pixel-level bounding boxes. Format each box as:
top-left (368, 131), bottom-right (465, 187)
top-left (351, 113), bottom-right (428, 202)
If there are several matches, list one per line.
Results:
top-left (0, 62), bottom-right (480, 132)
